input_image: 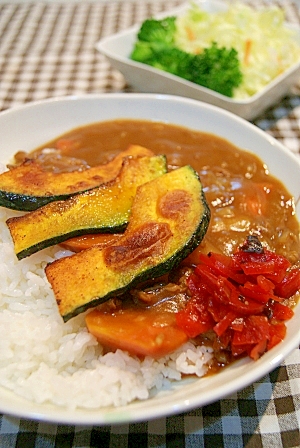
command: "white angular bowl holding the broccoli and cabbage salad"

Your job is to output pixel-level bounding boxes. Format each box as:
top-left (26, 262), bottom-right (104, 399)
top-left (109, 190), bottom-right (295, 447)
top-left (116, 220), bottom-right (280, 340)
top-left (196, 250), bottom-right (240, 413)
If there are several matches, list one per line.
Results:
top-left (96, 0), bottom-right (300, 120)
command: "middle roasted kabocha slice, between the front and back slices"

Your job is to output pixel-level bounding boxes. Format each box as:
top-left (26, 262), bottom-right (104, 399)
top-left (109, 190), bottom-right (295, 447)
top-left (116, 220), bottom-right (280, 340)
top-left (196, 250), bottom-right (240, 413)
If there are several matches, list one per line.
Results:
top-left (6, 156), bottom-right (167, 260)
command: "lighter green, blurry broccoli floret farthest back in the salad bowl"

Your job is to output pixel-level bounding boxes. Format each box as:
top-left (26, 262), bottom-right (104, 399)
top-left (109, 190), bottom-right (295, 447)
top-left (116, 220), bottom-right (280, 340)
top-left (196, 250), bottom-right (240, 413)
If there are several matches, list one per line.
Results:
top-left (138, 17), bottom-right (176, 45)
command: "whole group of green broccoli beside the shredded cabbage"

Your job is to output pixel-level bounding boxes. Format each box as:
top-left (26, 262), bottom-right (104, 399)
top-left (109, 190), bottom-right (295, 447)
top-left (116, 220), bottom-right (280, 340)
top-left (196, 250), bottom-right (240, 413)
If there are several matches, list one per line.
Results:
top-left (130, 17), bottom-right (243, 97)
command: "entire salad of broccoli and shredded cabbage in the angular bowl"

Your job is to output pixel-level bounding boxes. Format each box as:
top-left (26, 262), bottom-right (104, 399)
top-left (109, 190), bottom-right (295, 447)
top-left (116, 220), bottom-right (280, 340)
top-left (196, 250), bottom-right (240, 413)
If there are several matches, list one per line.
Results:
top-left (132, 2), bottom-right (300, 99)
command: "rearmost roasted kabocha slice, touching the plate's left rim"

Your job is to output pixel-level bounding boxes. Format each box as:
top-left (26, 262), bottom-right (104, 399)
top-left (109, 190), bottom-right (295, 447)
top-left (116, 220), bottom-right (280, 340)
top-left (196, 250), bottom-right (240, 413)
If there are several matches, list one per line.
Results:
top-left (0, 145), bottom-right (154, 211)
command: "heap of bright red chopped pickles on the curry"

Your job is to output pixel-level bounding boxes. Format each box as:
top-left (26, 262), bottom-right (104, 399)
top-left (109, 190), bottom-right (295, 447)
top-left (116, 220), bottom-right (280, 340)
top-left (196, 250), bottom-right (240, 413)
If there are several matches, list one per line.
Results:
top-left (176, 237), bottom-right (300, 359)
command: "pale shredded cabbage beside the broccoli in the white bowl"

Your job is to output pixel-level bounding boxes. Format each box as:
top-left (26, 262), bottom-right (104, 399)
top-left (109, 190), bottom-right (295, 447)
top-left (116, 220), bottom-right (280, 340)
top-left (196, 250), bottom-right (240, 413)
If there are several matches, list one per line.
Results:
top-left (175, 3), bottom-right (300, 99)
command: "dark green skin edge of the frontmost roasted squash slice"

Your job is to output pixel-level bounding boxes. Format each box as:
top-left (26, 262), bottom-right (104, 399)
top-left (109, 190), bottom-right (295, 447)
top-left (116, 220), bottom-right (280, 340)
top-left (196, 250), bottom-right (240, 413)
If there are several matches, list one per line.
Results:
top-left (62, 191), bottom-right (211, 322)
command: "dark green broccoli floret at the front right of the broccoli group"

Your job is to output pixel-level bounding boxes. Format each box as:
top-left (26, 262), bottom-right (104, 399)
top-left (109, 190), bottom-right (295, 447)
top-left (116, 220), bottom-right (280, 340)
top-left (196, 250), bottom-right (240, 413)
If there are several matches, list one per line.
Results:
top-left (187, 43), bottom-right (243, 97)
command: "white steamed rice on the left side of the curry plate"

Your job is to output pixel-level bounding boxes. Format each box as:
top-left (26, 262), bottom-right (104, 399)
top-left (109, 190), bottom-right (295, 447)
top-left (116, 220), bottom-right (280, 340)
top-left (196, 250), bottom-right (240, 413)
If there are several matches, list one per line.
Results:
top-left (0, 164), bottom-right (213, 409)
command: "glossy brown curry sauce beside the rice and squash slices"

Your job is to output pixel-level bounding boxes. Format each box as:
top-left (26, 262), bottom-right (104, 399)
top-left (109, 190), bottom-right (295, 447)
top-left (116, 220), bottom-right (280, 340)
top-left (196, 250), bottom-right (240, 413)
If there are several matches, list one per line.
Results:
top-left (20, 119), bottom-right (300, 373)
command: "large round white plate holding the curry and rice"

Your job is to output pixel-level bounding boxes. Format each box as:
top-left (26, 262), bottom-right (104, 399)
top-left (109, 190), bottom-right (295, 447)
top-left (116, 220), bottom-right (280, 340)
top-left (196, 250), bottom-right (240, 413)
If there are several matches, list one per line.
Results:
top-left (0, 94), bottom-right (300, 425)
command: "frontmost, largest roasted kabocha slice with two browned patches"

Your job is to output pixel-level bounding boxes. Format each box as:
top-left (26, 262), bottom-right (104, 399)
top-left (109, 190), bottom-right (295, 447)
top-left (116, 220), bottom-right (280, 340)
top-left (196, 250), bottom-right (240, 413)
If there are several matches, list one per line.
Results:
top-left (46, 166), bottom-right (210, 321)
